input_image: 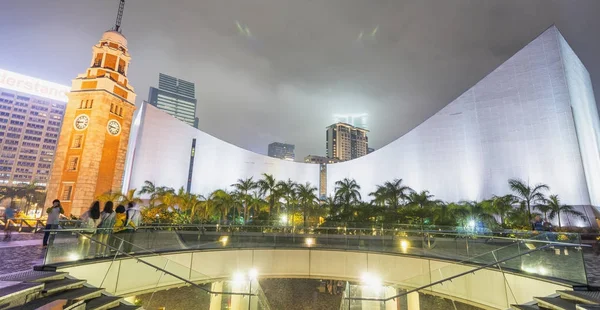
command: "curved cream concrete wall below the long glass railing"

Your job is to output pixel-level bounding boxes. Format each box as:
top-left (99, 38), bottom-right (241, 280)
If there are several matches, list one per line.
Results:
top-left (60, 249), bottom-right (570, 309)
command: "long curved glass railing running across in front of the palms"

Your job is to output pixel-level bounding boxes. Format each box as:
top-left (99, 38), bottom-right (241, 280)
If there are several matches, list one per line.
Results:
top-left (45, 225), bottom-right (587, 284)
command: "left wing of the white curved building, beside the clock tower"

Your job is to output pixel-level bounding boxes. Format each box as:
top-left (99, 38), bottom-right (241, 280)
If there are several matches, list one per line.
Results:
top-left (126, 103), bottom-right (319, 195)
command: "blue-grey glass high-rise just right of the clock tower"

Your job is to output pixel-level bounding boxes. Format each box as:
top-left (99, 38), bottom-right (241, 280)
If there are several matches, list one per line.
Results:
top-left (148, 73), bottom-right (198, 128)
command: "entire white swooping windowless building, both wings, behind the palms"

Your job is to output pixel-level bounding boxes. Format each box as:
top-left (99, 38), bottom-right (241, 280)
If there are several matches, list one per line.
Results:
top-left (124, 26), bottom-right (600, 211)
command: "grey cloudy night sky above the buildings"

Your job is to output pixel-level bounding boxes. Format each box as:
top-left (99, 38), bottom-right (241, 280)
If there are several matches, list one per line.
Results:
top-left (0, 0), bottom-right (600, 159)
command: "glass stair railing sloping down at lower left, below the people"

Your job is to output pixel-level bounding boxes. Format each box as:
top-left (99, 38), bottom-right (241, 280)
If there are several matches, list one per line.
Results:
top-left (45, 229), bottom-right (269, 310)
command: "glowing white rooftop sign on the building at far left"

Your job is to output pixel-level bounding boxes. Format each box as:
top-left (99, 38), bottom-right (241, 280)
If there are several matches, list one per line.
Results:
top-left (0, 69), bottom-right (71, 102)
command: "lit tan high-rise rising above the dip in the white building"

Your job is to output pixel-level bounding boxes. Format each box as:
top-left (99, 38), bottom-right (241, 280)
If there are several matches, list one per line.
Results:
top-left (326, 123), bottom-right (369, 161)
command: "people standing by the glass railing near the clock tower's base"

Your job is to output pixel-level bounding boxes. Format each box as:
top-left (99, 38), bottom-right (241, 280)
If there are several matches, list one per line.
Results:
top-left (43, 199), bottom-right (142, 257)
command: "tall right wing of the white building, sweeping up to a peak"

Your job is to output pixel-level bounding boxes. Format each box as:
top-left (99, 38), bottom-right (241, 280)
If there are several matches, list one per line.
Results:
top-left (327, 27), bottom-right (600, 205)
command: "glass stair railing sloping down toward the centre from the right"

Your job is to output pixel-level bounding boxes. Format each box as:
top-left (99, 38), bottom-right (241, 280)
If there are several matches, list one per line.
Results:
top-left (340, 238), bottom-right (586, 310)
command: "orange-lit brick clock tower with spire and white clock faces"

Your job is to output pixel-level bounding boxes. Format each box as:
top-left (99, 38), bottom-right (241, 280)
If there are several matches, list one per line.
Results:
top-left (45, 1), bottom-right (136, 216)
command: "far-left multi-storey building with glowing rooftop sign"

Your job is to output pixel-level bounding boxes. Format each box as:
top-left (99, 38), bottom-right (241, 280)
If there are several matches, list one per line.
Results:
top-left (0, 69), bottom-right (69, 187)
